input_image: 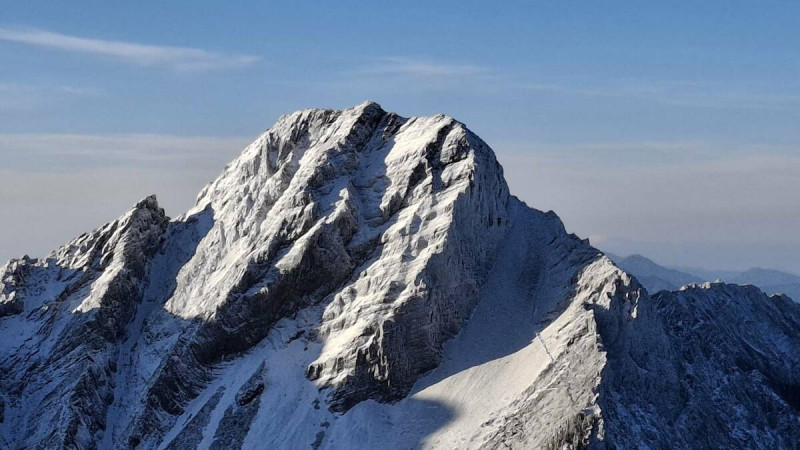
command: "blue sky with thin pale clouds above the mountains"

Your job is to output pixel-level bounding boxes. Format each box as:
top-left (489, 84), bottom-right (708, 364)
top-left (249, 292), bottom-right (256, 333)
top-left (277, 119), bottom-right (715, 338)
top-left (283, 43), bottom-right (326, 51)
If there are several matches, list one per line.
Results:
top-left (0, 1), bottom-right (800, 272)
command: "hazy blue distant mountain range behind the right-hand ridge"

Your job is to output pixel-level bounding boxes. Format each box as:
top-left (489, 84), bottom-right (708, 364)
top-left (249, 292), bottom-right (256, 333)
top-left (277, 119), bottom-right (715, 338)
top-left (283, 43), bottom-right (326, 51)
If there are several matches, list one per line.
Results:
top-left (606, 253), bottom-right (800, 302)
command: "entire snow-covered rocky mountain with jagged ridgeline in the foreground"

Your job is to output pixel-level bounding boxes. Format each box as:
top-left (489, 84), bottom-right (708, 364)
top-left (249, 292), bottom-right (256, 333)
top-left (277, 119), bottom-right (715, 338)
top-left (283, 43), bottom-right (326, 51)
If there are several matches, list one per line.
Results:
top-left (0, 103), bottom-right (800, 449)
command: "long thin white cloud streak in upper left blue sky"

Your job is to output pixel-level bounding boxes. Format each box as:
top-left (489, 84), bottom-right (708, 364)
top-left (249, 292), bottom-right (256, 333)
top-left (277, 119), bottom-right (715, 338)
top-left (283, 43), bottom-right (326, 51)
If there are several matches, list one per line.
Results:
top-left (0, 28), bottom-right (260, 71)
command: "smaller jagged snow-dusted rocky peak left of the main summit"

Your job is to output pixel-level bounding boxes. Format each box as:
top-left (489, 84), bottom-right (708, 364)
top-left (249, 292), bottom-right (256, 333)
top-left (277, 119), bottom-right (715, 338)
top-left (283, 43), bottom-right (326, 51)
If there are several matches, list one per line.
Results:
top-left (0, 197), bottom-right (168, 448)
